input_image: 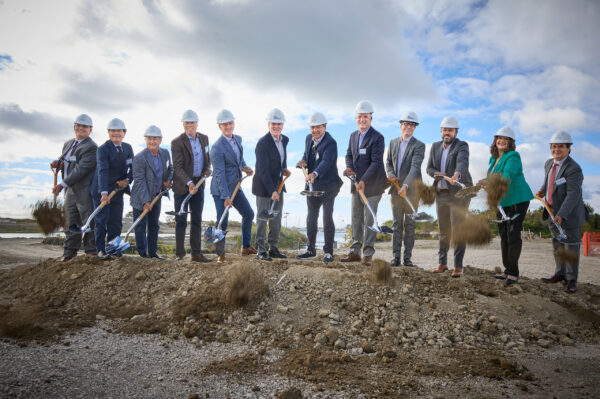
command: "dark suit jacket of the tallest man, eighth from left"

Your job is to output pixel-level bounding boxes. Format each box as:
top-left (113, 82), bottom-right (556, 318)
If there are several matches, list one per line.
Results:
top-left (346, 126), bottom-right (387, 197)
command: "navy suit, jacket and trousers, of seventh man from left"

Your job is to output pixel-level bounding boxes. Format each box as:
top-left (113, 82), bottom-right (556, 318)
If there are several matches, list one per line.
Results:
top-left (302, 132), bottom-right (343, 255)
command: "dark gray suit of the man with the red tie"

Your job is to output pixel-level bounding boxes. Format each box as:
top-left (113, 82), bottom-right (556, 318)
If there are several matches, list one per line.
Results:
top-left (540, 156), bottom-right (588, 281)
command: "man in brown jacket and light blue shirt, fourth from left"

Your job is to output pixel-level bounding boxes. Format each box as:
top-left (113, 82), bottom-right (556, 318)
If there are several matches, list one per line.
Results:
top-left (171, 109), bottom-right (211, 262)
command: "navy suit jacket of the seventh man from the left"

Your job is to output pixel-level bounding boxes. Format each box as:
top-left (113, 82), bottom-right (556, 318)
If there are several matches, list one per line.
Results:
top-left (302, 132), bottom-right (343, 192)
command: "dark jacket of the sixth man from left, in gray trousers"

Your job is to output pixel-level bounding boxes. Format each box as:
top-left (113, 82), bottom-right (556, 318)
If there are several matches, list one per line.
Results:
top-left (252, 132), bottom-right (290, 197)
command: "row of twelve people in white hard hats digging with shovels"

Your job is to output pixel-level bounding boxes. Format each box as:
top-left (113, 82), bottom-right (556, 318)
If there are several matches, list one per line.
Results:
top-left (51, 101), bottom-right (586, 292)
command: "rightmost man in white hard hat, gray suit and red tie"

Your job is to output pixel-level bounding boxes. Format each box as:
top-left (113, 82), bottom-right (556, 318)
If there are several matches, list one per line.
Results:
top-left (536, 131), bottom-right (589, 293)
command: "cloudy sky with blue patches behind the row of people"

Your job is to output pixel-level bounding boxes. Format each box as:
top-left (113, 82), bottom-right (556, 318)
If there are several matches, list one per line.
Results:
top-left (0, 0), bottom-right (600, 230)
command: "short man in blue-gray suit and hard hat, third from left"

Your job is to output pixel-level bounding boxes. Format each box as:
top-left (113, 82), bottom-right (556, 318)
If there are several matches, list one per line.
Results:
top-left (130, 125), bottom-right (173, 259)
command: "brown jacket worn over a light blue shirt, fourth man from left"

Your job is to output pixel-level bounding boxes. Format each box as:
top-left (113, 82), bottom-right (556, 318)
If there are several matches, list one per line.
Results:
top-left (171, 133), bottom-right (210, 195)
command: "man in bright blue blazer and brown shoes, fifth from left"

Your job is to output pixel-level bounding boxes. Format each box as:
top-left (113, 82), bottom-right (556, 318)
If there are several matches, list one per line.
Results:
top-left (210, 109), bottom-right (257, 264)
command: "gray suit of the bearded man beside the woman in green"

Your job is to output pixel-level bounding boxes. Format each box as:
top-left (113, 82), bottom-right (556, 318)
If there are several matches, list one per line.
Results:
top-left (427, 138), bottom-right (473, 269)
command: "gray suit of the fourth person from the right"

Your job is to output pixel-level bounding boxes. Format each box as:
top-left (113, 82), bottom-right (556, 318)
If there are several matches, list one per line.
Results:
top-left (385, 136), bottom-right (425, 263)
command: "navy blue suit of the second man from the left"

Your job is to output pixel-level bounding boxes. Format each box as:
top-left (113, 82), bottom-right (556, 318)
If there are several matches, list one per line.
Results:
top-left (90, 140), bottom-right (133, 251)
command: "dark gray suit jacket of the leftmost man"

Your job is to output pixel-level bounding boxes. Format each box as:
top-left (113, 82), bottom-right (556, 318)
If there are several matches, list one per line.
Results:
top-left (61, 137), bottom-right (98, 198)
